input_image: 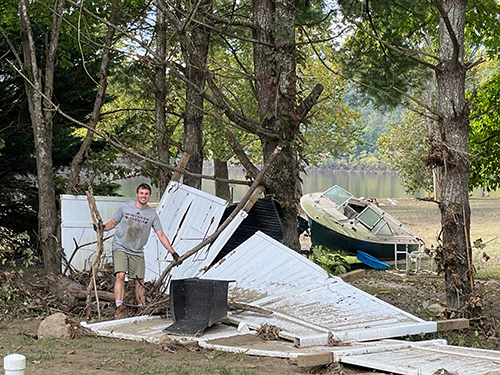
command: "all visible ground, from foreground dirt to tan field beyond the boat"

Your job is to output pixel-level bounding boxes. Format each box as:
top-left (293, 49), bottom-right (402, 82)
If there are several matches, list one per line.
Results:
top-left (0, 200), bottom-right (500, 375)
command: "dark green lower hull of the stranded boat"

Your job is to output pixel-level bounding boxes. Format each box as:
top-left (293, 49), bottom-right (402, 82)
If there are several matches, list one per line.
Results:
top-left (308, 217), bottom-right (420, 261)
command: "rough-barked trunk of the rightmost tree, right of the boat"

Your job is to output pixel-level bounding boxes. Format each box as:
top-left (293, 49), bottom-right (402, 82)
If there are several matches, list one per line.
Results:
top-left (436, 0), bottom-right (473, 309)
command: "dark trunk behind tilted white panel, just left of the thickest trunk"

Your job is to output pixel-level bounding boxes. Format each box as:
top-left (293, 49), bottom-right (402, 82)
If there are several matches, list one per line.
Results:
top-left (183, 0), bottom-right (212, 189)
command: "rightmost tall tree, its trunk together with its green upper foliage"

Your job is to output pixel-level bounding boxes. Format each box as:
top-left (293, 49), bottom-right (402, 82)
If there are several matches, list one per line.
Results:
top-left (340, 0), bottom-right (498, 309)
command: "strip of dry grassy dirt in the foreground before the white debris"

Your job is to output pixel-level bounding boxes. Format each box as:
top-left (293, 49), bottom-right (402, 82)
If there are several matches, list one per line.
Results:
top-left (0, 319), bottom-right (384, 375)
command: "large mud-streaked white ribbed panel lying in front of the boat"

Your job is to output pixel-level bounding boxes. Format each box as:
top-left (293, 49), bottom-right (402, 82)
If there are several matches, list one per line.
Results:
top-left (203, 232), bottom-right (437, 346)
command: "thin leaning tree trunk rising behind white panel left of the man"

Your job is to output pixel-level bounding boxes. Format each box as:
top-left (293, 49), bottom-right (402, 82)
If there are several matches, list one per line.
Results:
top-left (66, 0), bottom-right (122, 194)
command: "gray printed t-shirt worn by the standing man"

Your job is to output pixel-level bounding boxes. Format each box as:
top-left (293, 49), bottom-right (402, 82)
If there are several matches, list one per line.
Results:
top-left (113, 201), bottom-right (162, 255)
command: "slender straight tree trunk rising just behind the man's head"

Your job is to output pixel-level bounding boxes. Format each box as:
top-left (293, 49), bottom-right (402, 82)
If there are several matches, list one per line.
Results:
top-left (155, 0), bottom-right (170, 196)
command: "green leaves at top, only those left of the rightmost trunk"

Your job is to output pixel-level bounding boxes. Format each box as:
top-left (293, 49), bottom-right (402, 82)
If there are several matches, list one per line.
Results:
top-left (339, 0), bottom-right (439, 109)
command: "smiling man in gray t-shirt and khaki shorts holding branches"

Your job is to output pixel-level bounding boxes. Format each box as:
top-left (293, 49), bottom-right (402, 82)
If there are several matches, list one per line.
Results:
top-left (103, 184), bottom-right (179, 319)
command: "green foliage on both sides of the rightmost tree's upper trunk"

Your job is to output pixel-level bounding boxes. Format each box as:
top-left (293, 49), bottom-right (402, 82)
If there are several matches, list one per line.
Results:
top-left (339, 0), bottom-right (500, 108)
